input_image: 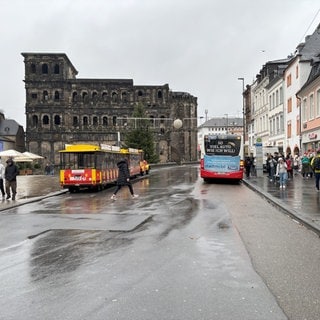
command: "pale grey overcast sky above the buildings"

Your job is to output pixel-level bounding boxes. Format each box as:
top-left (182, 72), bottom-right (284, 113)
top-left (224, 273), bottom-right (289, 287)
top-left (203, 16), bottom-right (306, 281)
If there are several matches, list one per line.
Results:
top-left (0, 0), bottom-right (320, 128)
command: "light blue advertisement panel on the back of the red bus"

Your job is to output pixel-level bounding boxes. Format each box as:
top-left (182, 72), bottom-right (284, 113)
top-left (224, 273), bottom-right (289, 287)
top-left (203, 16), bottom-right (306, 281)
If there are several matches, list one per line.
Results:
top-left (203, 155), bottom-right (240, 172)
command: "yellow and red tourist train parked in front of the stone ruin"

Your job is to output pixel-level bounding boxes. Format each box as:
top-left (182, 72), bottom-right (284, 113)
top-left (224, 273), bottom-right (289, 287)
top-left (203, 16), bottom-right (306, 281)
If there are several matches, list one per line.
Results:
top-left (59, 144), bottom-right (150, 192)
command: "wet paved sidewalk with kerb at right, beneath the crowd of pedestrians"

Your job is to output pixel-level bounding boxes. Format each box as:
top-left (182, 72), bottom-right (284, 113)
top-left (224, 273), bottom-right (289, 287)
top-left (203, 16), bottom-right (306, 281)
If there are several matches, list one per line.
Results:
top-left (243, 174), bottom-right (320, 235)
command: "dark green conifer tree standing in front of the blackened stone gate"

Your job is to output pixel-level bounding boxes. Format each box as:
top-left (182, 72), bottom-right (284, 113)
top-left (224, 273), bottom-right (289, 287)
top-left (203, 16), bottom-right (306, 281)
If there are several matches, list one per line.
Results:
top-left (124, 103), bottom-right (159, 163)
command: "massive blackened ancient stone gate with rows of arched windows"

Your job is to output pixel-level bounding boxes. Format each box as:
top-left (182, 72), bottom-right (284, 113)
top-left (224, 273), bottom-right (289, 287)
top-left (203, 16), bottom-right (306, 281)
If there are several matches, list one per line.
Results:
top-left (22, 53), bottom-right (197, 164)
